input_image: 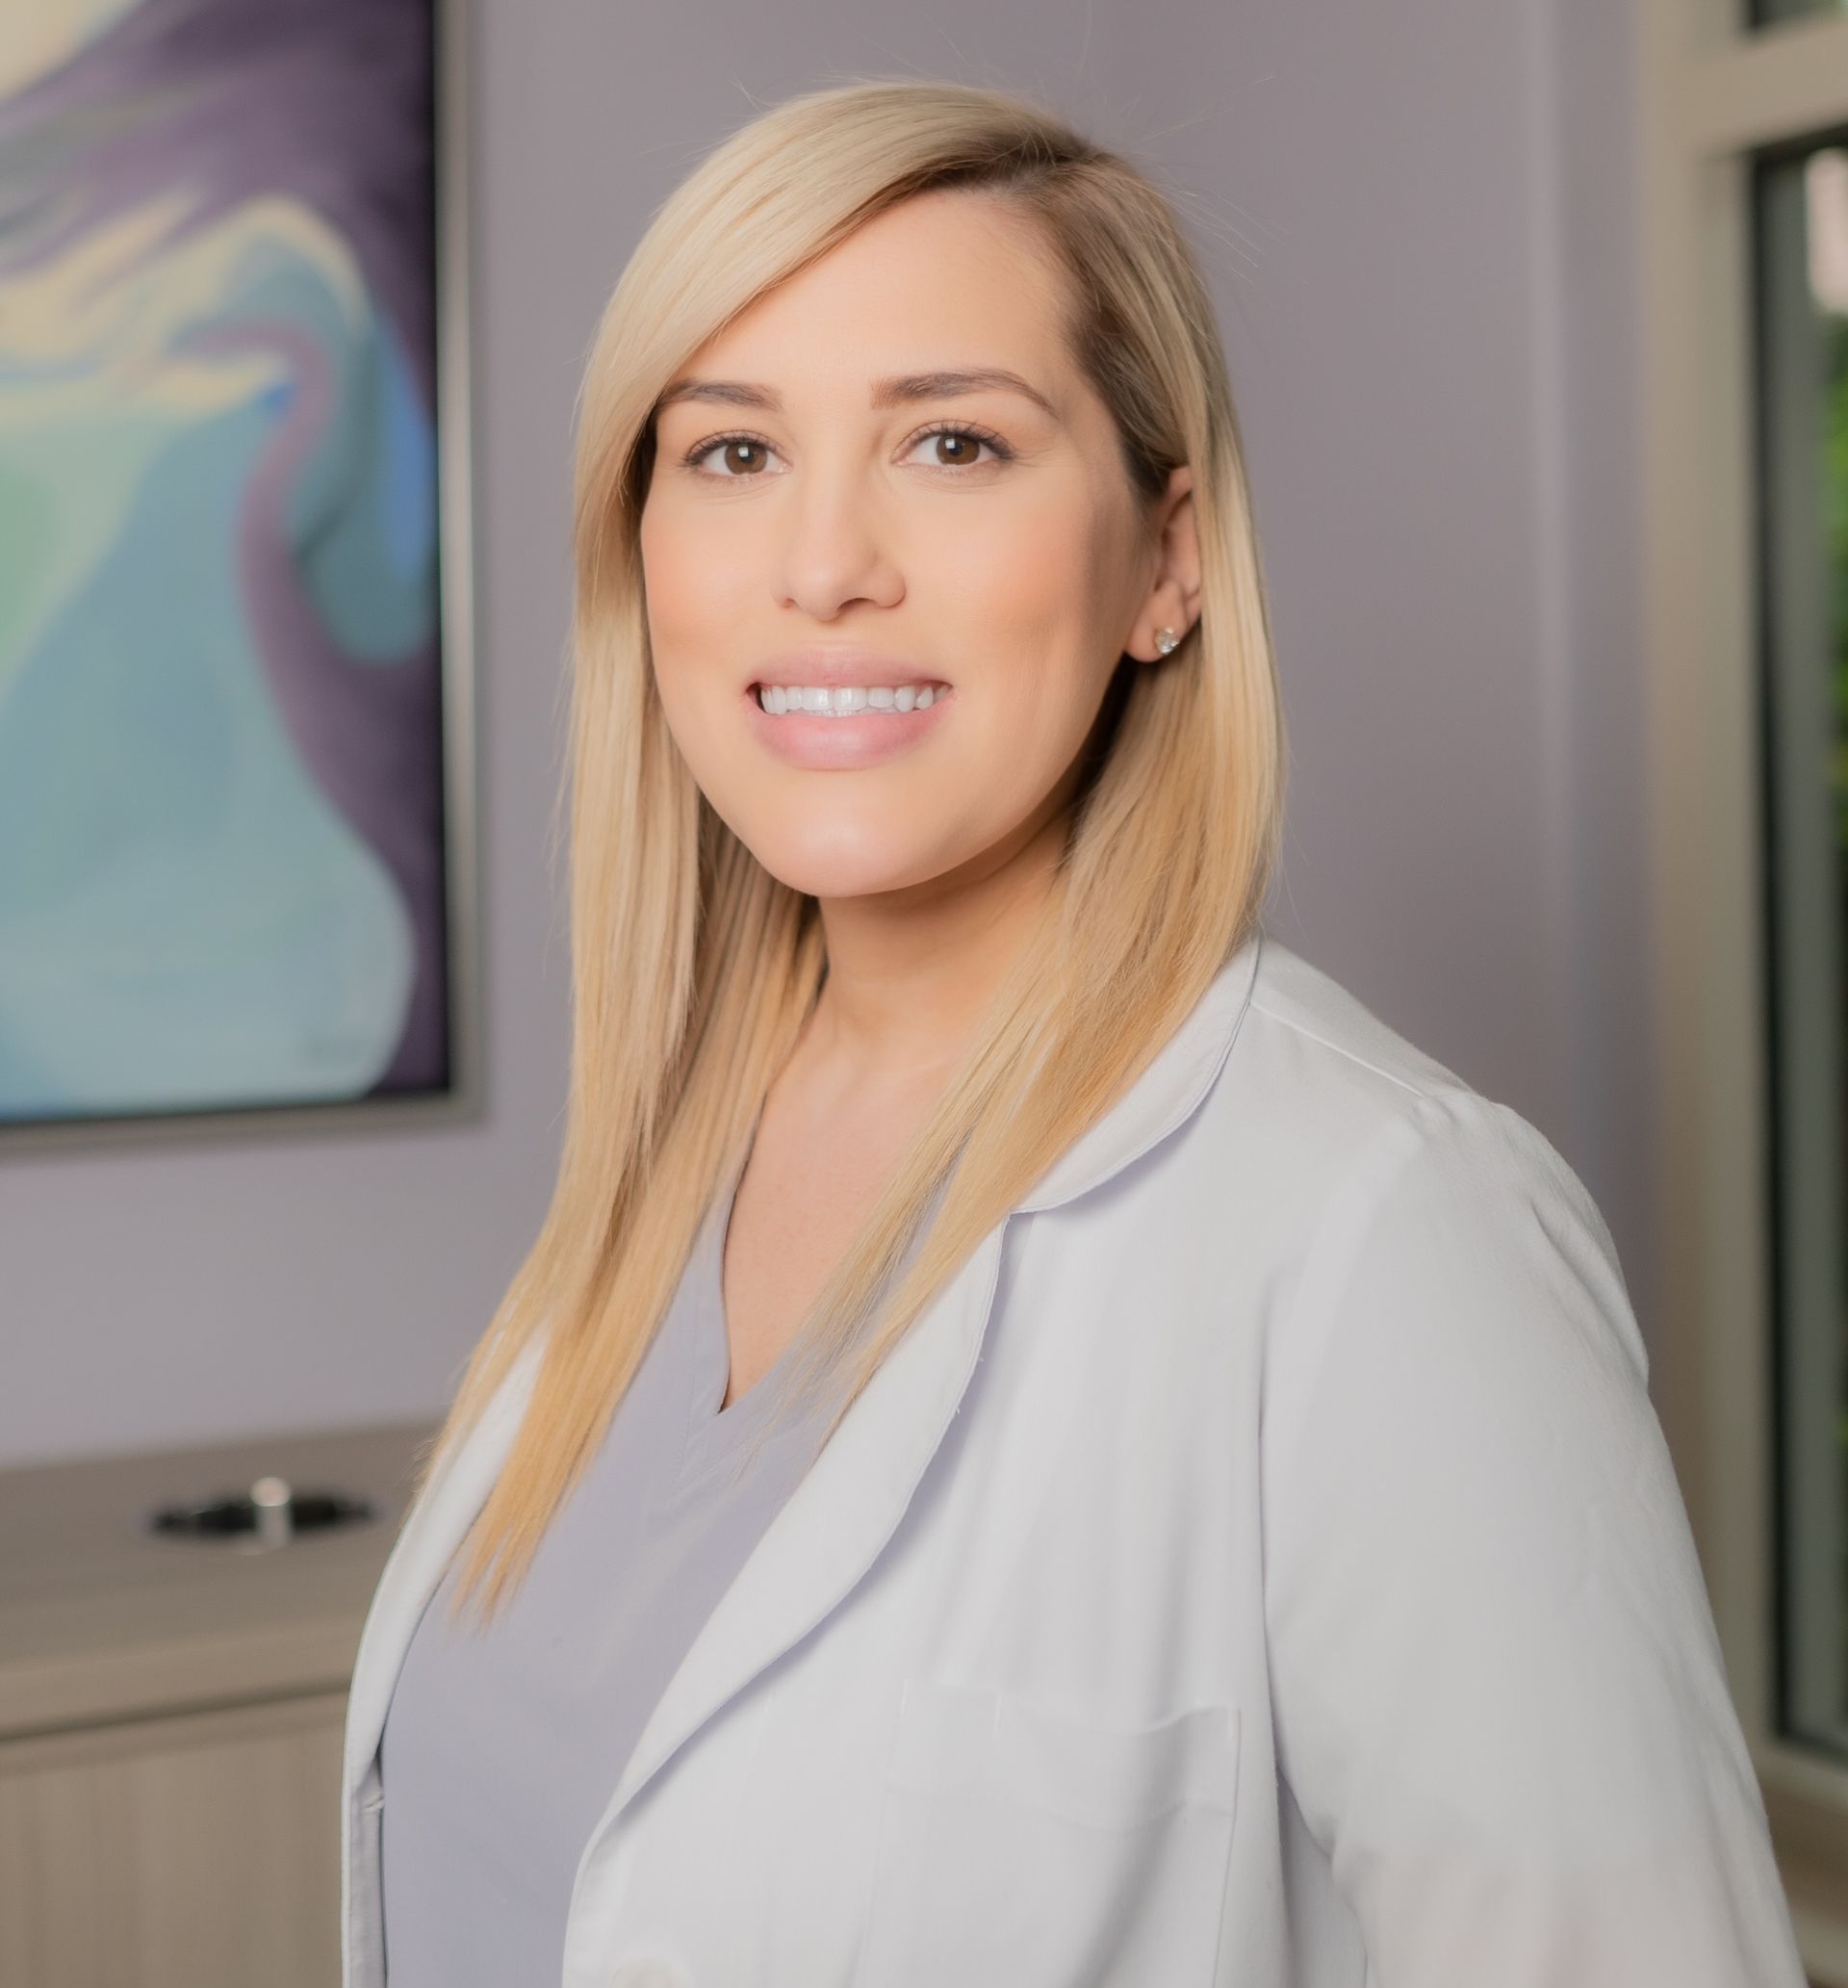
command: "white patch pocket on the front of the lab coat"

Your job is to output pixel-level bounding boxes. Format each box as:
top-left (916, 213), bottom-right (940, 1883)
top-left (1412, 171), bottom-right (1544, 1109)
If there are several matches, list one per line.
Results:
top-left (855, 1678), bottom-right (1238, 1988)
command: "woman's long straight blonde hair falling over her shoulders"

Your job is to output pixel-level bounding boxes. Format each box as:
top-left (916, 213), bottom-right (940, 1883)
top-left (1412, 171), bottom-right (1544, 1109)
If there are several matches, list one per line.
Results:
top-left (420, 78), bottom-right (1286, 1622)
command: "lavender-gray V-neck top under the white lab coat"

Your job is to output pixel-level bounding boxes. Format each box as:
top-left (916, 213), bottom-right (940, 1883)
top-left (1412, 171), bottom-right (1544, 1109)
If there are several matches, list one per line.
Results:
top-left (379, 1135), bottom-right (821, 1988)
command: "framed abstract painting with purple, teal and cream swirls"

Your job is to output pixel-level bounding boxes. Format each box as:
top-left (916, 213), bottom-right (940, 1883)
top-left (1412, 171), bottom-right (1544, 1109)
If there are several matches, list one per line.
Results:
top-left (0, 0), bottom-right (479, 1155)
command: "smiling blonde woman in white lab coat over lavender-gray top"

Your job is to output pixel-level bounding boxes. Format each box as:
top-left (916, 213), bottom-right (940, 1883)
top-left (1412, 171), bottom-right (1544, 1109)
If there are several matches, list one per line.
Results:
top-left (344, 80), bottom-right (1803, 1988)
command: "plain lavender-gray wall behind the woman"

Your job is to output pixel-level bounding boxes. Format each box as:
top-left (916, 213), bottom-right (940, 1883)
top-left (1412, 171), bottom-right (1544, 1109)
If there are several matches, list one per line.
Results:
top-left (0, 0), bottom-right (1654, 1461)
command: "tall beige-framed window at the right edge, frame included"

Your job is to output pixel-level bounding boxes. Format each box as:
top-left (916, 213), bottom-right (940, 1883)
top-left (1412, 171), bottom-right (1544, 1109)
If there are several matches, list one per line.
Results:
top-left (1635, 0), bottom-right (1848, 1964)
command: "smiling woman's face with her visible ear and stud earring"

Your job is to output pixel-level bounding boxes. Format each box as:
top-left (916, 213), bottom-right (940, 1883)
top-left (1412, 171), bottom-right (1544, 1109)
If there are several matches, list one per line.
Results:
top-left (642, 191), bottom-right (1193, 898)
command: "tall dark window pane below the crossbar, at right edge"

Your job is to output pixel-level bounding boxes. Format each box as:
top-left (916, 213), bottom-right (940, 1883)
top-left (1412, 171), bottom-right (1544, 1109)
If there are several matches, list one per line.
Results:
top-left (1753, 137), bottom-right (1848, 1757)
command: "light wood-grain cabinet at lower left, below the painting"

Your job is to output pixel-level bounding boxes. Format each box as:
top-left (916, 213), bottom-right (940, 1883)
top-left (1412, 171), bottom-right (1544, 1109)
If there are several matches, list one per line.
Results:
top-left (0, 1424), bottom-right (431, 1988)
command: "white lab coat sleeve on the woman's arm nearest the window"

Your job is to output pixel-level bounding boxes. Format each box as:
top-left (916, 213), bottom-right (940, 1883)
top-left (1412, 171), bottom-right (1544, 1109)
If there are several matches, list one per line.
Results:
top-left (1262, 1090), bottom-right (1803, 1988)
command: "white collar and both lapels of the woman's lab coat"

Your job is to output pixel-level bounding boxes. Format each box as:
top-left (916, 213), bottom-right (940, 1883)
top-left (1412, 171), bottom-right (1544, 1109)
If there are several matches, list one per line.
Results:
top-left (347, 932), bottom-right (1262, 1813)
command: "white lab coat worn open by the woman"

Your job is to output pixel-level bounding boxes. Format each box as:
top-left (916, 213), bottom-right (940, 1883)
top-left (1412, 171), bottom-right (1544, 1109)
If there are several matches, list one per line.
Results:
top-left (342, 937), bottom-right (1803, 1988)
